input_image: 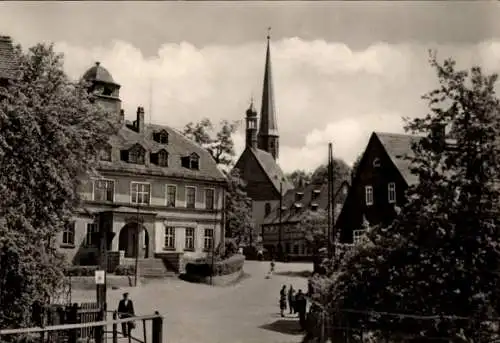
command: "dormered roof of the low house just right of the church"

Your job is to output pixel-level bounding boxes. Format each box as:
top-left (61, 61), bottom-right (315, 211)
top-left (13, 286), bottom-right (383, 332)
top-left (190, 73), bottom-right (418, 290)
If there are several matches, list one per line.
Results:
top-left (263, 181), bottom-right (349, 225)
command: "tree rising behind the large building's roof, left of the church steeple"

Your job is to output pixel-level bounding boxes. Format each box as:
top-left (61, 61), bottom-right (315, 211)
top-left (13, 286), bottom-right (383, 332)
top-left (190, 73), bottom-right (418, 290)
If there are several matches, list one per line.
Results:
top-left (183, 118), bottom-right (238, 167)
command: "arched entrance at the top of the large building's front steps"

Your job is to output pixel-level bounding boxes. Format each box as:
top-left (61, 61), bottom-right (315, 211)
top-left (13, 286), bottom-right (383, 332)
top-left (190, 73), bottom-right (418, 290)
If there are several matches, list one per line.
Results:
top-left (118, 223), bottom-right (149, 258)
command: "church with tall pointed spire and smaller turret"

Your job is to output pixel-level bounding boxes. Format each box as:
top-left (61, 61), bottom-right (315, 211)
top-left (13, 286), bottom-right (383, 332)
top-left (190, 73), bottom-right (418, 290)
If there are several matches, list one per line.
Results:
top-left (233, 35), bottom-right (293, 239)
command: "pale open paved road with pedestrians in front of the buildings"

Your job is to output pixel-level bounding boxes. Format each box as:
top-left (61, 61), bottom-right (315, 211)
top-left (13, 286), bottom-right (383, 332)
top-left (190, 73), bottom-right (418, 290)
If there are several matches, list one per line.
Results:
top-left (75, 261), bottom-right (312, 343)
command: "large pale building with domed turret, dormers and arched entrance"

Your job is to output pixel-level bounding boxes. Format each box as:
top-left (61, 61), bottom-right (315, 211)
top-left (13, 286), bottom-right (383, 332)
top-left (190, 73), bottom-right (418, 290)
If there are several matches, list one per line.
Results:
top-left (60, 63), bottom-right (226, 271)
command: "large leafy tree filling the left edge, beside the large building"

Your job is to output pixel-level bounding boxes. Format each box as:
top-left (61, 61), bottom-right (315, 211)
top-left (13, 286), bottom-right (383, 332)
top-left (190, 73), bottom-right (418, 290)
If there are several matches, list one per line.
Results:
top-left (0, 44), bottom-right (118, 328)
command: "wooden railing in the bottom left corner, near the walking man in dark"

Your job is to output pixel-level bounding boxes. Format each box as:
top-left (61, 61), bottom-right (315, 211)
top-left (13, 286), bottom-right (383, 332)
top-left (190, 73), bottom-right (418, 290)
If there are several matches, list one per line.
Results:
top-left (0, 312), bottom-right (163, 343)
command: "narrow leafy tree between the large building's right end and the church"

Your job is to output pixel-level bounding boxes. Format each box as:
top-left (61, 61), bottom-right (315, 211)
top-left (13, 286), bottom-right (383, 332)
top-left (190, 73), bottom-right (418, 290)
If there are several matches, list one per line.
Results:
top-left (225, 169), bottom-right (256, 245)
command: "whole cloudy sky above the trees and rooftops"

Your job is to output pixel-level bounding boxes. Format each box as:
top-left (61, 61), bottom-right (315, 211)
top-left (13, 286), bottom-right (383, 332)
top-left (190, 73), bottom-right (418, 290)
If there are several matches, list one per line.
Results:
top-left (0, 1), bottom-right (500, 172)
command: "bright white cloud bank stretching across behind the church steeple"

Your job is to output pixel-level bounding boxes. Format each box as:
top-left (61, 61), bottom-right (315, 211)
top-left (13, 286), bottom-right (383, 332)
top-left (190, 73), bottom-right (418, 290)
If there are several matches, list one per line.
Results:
top-left (51, 38), bottom-right (500, 172)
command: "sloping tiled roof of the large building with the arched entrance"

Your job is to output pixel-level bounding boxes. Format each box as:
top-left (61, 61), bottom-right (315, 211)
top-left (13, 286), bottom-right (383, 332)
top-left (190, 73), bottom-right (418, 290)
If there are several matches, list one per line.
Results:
top-left (100, 122), bottom-right (226, 181)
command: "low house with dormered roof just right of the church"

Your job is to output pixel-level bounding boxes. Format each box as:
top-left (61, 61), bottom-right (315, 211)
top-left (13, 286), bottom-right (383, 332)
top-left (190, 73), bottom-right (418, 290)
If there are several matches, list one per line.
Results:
top-left (262, 181), bottom-right (349, 259)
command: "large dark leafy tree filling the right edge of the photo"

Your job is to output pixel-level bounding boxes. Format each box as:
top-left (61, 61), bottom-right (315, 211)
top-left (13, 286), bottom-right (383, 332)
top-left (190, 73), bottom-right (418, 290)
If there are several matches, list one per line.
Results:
top-left (330, 55), bottom-right (500, 341)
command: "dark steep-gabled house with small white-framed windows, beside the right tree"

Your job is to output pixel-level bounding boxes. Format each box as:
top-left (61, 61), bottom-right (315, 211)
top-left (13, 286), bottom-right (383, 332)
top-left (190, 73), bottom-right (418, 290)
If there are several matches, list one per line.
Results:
top-left (337, 132), bottom-right (420, 243)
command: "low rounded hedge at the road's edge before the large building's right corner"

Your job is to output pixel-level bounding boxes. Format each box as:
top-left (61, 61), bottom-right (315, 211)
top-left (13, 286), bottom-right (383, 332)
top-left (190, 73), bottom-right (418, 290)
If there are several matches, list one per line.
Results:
top-left (186, 254), bottom-right (245, 277)
